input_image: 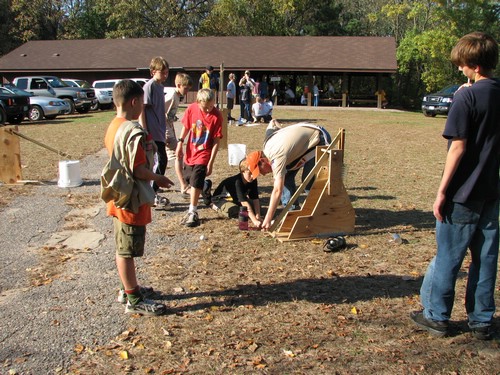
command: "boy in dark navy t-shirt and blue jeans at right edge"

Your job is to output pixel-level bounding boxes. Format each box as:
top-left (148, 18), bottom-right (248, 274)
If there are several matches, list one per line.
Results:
top-left (410, 32), bottom-right (500, 340)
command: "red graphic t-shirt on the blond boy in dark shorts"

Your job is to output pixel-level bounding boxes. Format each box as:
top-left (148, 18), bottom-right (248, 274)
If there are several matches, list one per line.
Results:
top-left (182, 103), bottom-right (222, 165)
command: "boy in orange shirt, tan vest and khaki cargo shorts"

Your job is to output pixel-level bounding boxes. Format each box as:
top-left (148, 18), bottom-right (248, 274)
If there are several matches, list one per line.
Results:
top-left (101, 80), bottom-right (173, 316)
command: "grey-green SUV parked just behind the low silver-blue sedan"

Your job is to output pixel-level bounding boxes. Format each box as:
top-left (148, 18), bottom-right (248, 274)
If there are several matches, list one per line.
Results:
top-left (13, 76), bottom-right (95, 113)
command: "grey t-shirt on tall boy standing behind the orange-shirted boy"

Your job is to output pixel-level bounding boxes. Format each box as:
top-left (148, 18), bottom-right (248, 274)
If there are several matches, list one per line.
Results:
top-left (143, 79), bottom-right (167, 143)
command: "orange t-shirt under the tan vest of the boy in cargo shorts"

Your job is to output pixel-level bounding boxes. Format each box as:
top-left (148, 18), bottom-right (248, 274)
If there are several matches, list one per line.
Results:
top-left (104, 117), bottom-right (151, 226)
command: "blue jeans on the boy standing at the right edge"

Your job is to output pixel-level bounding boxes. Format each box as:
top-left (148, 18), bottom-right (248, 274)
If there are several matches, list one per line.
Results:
top-left (420, 200), bottom-right (499, 328)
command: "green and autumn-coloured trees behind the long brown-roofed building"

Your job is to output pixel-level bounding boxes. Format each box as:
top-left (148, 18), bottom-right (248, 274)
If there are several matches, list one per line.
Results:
top-left (0, 0), bottom-right (500, 107)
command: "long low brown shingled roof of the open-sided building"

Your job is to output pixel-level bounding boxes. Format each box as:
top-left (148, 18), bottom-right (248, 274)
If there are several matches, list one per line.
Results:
top-left (0, 36), bottom-right (397, 73)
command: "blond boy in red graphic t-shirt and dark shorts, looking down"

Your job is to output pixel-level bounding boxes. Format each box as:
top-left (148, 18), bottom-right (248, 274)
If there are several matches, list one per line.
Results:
top-left (176, 89), bottom-right (222, 227)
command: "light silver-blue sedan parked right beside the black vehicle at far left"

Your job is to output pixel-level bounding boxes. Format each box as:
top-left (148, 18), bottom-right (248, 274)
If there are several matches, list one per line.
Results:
top-left (4, 85), bottom-right (71, 121)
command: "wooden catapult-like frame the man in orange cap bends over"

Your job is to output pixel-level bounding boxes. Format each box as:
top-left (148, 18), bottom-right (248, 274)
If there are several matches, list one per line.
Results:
top-left (270, 129), bottom-right (355, 242)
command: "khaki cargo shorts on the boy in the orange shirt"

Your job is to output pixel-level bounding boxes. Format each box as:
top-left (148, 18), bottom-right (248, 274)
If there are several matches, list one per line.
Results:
top-left (113, 217), bottom-right (146, 258)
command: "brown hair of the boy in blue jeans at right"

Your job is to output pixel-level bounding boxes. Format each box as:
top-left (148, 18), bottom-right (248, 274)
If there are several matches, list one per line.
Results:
top-left (451, 31), bottom-right (498, 70)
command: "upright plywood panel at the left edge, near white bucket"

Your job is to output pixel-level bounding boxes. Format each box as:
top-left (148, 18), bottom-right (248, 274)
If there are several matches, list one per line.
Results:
top-left (0, 126), bottom-right (22, 184)
